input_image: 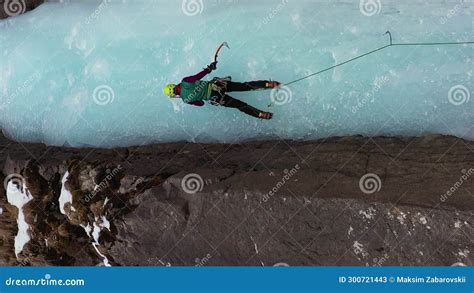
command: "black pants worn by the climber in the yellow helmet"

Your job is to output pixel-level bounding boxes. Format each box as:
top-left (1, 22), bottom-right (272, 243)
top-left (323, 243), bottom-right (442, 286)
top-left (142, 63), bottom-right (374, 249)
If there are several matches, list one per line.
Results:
top-left (211, 80), bottom-right (268, 118)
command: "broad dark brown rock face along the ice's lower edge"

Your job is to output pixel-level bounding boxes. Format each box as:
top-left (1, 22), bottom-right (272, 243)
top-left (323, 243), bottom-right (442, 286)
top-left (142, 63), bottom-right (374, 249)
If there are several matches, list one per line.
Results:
top-left (0, 131), bottom-right (474, 266)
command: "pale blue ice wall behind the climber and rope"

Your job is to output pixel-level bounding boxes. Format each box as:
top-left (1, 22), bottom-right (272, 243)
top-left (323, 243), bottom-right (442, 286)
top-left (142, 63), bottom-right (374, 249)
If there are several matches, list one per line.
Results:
top-left (0, 0), bottom-right (474, 147)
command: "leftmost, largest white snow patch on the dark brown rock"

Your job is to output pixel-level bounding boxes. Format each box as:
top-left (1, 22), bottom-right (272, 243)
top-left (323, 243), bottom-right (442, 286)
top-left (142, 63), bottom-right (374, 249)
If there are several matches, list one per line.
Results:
top-left (7, 181), bottom-right (33, 258)
